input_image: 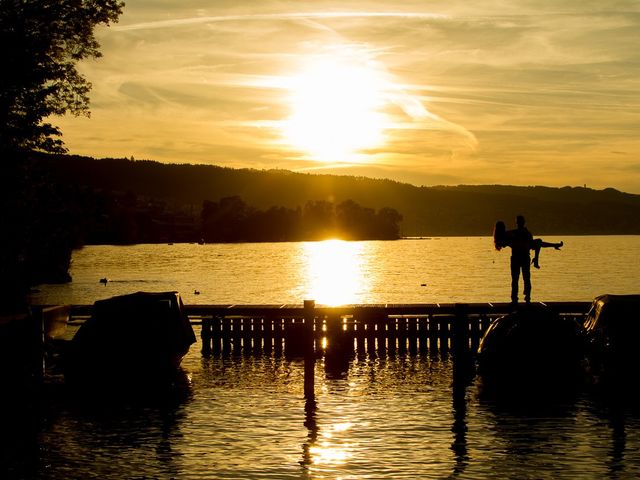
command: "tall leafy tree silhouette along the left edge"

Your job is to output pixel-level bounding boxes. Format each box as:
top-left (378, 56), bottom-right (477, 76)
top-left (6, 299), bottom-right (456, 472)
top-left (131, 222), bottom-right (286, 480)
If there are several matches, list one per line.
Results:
top-left (0, 0), bottom-right (124, 311)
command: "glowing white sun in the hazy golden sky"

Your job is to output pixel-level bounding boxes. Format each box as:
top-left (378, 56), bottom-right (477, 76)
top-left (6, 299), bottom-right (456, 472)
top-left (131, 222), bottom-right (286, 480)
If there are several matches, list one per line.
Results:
top-left (283, 55), bottom-right (388, 162)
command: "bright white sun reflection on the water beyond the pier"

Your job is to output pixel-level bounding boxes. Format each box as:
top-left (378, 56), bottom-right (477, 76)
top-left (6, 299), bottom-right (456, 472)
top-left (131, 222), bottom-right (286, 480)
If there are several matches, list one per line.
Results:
top-left (304, 240), bottom-right (370, 306)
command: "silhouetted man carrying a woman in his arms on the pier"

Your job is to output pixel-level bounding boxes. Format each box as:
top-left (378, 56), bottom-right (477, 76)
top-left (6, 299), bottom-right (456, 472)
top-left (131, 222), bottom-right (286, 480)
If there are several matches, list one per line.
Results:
top-left (493, 215), bottom-right (564, 303)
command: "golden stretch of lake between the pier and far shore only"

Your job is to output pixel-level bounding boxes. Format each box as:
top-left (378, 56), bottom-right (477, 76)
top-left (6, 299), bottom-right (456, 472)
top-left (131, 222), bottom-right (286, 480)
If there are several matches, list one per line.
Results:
top-left (27, 236), bottom-right (640, 305)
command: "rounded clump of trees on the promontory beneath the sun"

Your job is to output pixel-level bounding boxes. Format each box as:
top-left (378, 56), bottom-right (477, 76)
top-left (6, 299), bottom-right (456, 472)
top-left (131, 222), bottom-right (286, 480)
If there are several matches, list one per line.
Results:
top-left (201, 196), bottom-right (402, 242)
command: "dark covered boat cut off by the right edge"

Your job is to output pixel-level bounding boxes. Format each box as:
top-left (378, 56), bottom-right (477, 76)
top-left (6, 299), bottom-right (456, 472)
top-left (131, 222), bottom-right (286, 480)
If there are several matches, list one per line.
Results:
top-left (584, 294), bottom-right (640, 377)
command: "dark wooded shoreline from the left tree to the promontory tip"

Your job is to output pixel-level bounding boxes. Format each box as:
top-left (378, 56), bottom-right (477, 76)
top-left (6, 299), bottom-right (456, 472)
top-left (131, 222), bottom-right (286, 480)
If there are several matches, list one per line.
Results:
top-left (80, 191), bottom-right (402, 245)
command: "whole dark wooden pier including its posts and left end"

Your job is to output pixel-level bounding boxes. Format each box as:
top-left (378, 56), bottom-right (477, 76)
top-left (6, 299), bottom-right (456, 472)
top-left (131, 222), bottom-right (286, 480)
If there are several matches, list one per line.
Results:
top-left (0, 300), bottom-right (591, 399)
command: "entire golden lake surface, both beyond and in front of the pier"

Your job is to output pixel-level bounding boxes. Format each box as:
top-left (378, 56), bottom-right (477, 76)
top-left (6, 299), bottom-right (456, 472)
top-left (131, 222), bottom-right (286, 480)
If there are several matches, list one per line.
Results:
top-left (7, 237), bottom-right (640, 479)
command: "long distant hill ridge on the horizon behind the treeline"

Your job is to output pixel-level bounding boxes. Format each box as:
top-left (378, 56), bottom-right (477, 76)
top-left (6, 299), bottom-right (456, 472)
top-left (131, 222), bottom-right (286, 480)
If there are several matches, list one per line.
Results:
top-left (41, 155), bottom-right (640, 236)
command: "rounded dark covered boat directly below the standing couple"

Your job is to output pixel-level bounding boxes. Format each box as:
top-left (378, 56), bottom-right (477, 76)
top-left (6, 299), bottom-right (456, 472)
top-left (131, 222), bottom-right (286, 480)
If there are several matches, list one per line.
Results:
top-left (477, 306), bottom-right (584, 387)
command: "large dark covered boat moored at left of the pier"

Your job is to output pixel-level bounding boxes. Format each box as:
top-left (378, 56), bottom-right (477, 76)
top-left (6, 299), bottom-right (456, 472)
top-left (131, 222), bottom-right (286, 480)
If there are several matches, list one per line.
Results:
top-left (64, 292), bottom-right (196, 386)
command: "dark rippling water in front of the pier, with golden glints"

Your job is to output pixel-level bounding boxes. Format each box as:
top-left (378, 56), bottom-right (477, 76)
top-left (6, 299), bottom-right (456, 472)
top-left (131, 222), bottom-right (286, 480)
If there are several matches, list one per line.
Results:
top-left (0, 328), bottom-right (640, 479)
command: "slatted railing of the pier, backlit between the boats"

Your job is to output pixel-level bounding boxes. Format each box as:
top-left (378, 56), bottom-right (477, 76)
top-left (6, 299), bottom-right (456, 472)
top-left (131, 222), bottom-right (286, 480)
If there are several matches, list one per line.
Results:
top-left (70, 301), bottom-right (591, 355)
